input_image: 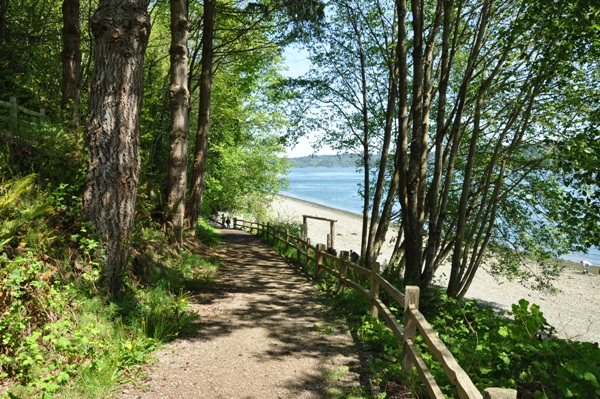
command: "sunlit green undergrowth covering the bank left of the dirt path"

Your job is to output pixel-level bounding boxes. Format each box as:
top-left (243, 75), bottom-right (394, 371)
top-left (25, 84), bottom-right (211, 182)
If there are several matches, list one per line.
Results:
top-left (0, 175), bottom-right (223, 399)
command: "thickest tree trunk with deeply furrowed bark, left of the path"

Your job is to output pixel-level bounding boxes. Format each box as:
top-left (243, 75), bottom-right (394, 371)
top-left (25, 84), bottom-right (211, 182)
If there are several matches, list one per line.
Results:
top-left (82, 0), bottom-right (151, 296)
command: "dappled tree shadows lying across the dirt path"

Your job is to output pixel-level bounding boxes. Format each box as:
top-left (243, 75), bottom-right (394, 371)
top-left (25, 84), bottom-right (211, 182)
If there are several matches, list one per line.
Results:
top-left (182, 229), bottom-right (371, 398)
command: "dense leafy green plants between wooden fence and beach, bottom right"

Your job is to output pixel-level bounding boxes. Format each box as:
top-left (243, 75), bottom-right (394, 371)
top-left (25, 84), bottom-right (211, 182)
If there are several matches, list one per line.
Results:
top-left (419, 294), bottom-right (600, 398)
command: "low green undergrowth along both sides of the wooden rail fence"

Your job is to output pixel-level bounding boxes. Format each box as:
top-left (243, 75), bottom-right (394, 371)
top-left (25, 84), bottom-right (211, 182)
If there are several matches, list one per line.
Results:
top-left (264, 222), bottom-right (600, 399)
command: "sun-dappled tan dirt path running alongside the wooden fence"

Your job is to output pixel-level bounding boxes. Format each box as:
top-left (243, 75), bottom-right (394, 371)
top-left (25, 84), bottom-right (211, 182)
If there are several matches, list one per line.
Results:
top-left (115, 230), bottom-right (369, 399)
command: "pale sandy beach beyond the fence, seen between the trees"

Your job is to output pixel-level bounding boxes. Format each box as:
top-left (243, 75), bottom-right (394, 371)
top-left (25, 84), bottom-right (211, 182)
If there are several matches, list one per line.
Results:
top-left (270, 196), bottom-right (600, 342)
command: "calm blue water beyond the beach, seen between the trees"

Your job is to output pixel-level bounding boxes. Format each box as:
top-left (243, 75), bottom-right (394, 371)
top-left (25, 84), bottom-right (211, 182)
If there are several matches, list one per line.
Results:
top-left (281, 168), bottom-right (600, 266)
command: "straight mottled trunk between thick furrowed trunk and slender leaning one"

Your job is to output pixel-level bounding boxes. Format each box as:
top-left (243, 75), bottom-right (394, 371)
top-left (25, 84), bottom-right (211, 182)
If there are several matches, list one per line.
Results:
top-left (166, 0), bottom-right (190, 244)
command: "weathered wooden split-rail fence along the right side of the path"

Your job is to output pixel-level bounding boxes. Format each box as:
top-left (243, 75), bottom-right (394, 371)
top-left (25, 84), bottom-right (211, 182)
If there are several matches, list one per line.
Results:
top-left (233, 218), bottom-right (517, 399)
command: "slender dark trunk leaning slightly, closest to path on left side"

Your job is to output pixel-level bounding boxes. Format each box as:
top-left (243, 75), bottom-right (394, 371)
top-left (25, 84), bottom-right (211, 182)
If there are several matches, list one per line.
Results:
top-left (186, 0), bottom-right (215, 229)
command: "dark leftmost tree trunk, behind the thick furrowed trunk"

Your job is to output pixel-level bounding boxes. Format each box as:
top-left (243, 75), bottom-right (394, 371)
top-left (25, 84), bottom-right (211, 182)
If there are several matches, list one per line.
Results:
top-left (60, 0), bottom-right (81, 128)
